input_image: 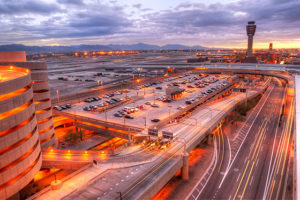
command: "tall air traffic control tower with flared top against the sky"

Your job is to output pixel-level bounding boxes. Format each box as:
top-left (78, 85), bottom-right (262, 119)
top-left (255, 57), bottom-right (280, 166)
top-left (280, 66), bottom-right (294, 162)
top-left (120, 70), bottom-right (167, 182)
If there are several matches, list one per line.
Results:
top-left (244, 21), bottom-right (257, 63)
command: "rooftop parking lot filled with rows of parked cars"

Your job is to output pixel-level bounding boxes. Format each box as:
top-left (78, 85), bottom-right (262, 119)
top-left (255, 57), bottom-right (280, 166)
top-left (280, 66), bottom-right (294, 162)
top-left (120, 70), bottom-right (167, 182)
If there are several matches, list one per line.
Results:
top-left (55, 74), bottom-right (230, 127)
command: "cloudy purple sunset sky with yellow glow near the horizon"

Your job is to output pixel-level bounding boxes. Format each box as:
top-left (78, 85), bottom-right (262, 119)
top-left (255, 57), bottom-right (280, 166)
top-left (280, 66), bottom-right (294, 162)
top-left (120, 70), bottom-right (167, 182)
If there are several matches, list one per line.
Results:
top-left (0, 0), bottom-right (300, 48)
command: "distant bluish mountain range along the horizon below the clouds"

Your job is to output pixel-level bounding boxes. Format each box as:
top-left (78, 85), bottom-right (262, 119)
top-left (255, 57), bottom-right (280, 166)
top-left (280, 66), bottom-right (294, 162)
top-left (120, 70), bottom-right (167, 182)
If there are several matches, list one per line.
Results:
top-left (0, 43), bottom-right (206, 54)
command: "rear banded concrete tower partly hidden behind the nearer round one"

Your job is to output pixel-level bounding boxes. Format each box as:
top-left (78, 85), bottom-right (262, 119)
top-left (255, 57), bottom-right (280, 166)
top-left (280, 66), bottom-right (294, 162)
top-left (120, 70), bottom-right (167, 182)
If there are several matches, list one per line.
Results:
top-left (0, 52), bottom-right (55, 148)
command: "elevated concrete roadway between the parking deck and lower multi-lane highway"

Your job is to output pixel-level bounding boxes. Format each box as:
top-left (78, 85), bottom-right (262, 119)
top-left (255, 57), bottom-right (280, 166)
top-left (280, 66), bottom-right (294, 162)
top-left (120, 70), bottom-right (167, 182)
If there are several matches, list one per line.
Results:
top-left (34, 88), bottom-right (257, 199)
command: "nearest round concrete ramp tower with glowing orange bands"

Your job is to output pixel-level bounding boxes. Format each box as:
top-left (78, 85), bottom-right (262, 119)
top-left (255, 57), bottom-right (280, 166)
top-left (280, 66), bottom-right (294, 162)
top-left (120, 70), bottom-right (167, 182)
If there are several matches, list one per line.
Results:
top-left (0, 65), bottom-right (42, 199)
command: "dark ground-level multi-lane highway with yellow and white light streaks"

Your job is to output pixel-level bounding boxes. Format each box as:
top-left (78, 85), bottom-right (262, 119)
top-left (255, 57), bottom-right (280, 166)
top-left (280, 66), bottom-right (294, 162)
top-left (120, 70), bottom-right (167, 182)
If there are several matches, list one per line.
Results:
top-left (189, 81), bottom-right (292, 199)
